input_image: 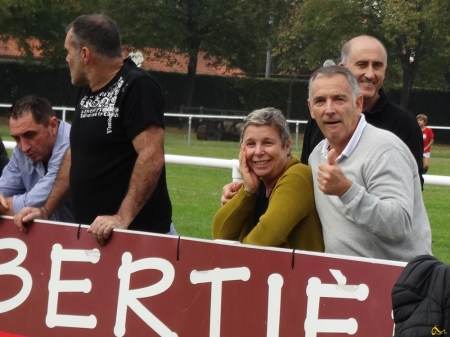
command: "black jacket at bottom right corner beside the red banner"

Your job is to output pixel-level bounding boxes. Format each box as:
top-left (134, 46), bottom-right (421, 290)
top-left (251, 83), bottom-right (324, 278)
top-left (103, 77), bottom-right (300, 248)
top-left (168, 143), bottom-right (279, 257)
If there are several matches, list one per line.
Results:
top-left (392, 255), bottom-right (450, 337)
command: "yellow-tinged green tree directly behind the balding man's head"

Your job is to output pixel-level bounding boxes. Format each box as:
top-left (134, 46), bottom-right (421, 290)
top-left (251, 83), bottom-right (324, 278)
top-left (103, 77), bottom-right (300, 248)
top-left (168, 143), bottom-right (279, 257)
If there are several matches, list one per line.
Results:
top-left (276, 0), bottom-right (450, 107)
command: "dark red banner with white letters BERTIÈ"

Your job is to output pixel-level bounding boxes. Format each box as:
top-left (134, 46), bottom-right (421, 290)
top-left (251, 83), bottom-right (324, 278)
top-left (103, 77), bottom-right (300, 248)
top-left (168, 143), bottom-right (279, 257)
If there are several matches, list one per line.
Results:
top-left (0, 218), bottom-right (404, 337)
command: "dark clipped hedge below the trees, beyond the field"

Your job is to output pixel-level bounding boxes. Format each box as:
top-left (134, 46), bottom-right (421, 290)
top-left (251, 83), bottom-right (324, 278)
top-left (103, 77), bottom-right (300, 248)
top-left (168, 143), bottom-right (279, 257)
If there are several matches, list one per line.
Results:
top-left (0, 62), bottom-right (450, 144)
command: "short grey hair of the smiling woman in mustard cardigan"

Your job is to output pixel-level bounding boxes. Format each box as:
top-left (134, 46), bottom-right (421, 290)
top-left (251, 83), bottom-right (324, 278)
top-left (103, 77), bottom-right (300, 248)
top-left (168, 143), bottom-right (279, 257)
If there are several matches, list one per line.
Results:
top-left (241, 108), bottom-right (291, 146)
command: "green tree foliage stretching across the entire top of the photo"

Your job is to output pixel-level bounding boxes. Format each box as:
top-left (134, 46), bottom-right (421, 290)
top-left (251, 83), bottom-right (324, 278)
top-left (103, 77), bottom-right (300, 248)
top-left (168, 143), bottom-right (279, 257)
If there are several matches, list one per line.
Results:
top-left (0, 0), bottom-right (450, 106)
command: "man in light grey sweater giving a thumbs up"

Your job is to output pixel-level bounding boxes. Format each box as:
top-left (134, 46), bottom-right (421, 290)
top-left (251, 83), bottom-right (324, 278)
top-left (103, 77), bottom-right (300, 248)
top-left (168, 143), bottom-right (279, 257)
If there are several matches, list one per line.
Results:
top-left (308, 66), bottom-right (431, 261)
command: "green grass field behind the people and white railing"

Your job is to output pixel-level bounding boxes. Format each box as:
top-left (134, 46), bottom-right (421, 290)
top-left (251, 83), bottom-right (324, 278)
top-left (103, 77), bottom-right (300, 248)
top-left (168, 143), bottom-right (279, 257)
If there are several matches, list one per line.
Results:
top-left (0, 123), bottom-right (450, 264)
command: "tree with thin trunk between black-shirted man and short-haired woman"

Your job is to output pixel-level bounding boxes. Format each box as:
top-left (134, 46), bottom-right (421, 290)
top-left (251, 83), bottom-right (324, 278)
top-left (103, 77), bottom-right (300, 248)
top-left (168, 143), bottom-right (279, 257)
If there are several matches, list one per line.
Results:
top-left (104, 0), bottom-right (289, 106)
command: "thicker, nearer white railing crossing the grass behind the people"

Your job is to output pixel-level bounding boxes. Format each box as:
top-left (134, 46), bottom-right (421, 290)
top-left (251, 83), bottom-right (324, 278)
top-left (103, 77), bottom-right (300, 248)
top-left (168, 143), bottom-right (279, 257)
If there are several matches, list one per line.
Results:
top-left (3, 141), bottom-right (450, 186)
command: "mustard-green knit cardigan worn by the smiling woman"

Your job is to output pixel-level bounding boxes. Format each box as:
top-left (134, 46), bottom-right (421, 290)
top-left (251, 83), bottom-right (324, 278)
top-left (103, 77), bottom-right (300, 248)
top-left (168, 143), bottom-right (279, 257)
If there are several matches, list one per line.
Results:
top-left (212, 156), bottom-right (324, 252)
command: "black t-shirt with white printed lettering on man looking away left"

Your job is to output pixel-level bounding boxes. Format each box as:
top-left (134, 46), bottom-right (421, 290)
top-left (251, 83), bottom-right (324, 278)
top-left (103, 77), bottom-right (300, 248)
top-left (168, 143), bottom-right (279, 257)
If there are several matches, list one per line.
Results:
top-left (70, 59), bottom-right (172, 233)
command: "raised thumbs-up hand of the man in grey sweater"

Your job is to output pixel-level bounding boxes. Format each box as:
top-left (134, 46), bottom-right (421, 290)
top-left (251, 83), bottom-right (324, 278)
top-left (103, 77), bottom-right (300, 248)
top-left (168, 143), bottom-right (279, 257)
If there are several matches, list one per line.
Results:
top-left (317, 149), bottom-right (353, 197)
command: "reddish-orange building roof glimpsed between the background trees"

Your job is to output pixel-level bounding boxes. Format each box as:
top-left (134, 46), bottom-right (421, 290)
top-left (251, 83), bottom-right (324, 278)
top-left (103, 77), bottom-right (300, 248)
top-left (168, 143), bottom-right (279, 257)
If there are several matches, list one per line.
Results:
top-left (0, 38), bottom-right (244, 76)
